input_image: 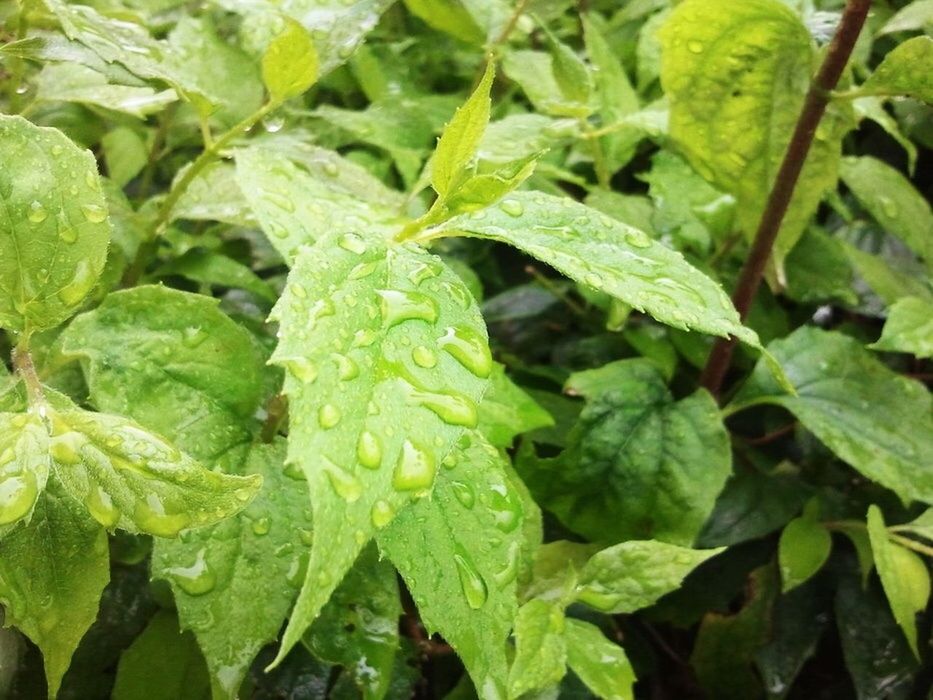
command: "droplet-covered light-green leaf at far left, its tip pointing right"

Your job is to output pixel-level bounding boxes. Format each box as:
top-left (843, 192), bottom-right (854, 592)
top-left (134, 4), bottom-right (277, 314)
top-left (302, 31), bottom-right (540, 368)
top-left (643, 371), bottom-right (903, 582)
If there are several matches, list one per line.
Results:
top-left (48, 399), bottom-right (262, 537)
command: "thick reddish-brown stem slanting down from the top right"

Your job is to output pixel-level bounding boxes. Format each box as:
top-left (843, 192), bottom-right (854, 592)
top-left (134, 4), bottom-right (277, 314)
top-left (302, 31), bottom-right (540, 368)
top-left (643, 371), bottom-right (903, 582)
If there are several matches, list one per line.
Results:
top-left (700, 0), bottom-right (871, 395)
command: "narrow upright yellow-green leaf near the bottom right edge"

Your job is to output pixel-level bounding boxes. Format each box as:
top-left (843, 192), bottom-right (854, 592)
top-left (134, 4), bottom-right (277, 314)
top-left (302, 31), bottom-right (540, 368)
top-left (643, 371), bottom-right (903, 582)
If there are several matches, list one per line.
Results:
top-left (868, 505), bottom-right (930, 659)
